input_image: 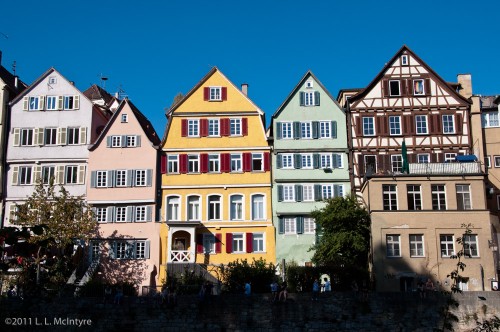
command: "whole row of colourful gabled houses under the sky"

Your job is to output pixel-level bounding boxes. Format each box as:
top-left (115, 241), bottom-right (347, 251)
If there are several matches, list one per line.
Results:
top-left (0, 46), bottom-right (500, 291)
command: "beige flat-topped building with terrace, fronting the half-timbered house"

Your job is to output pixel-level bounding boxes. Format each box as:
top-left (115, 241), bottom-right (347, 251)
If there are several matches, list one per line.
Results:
top-left (361, 163), bottom-right (496, 291)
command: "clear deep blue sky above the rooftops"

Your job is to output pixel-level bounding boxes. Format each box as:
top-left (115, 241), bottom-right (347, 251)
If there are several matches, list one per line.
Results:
top-left (0, 0), bottom-right (500, 136)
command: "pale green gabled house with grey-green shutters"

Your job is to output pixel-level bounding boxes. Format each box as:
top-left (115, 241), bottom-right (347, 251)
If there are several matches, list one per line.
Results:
top-left (269, 71), bottom-right (351, 266)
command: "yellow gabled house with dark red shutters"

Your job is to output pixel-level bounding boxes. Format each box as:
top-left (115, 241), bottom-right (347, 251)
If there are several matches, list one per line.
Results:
top-left (160, 67), bottom-right (276, 278)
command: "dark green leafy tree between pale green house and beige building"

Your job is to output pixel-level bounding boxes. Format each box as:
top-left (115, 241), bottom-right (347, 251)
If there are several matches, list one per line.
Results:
top-left (311, 196), bottom-right (370, 268)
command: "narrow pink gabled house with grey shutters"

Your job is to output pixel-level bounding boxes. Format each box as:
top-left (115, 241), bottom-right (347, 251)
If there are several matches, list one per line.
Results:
top-left (87, 99), bottom-right (160, 294)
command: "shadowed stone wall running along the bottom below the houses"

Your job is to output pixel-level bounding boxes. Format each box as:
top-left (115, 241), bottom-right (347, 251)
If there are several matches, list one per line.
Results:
top-left (0, 292), bottom-right (500, 332)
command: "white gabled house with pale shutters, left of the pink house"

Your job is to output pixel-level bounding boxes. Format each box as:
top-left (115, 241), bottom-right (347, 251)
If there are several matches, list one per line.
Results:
top-left (4, 68), bottom-right (108, 225)
